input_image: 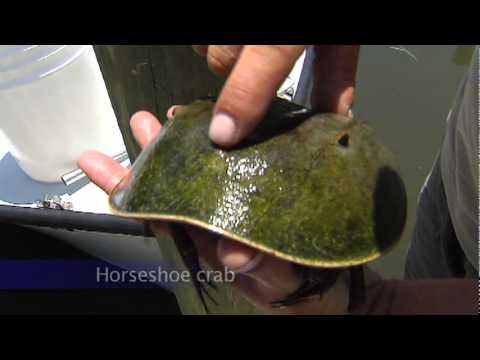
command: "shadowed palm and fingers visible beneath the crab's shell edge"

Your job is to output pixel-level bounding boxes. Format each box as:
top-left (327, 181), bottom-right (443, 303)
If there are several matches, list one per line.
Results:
top-left (171, 226), bottom-right (348, 314)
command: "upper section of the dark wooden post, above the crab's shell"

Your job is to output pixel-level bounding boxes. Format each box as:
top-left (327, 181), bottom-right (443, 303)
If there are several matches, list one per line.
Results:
top-left (94, 45), bottom-right (223, 161)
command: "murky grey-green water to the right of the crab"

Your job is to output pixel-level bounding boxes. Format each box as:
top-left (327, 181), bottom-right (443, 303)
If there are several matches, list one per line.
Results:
top-left (354, 45), bottom-right (473, 278)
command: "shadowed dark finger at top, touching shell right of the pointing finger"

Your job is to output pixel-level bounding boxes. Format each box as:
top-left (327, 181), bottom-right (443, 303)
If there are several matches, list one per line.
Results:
top-left (312, 45), bottom-right (360, 116)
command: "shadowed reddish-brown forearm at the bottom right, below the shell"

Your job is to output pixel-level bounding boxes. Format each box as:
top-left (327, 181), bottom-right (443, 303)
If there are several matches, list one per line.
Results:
top-left (359, 279), bottom-right (478, 315)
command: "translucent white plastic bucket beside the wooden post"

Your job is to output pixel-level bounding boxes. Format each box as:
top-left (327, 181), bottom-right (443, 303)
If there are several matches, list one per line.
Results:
top-left (0, 45), bottom-right (124, 182)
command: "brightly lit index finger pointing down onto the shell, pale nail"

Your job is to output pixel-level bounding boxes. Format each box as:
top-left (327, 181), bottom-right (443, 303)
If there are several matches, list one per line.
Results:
top-left (209, 45), bottom-right (304, 147)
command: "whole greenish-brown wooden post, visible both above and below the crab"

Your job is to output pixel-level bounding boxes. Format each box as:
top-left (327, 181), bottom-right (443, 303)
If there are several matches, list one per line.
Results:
top-left (94, 45), bottom-right (261, 314)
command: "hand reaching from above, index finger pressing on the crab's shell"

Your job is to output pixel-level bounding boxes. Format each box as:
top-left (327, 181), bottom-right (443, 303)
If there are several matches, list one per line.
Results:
top-left (193, 45), bottom-right (360, 147)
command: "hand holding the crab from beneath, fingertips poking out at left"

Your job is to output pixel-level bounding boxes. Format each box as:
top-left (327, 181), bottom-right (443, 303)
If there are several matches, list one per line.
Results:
top-left (79, 107), bottom-right (348, 314)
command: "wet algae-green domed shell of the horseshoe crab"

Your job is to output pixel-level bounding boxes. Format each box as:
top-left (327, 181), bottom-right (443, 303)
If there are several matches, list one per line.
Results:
top-left (110, 99), bottom-right (406, 268)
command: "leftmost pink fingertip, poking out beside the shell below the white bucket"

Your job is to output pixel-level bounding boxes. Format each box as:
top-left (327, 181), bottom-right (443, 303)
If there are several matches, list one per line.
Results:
top-left (78, 151), bottom-right (128, 194)
